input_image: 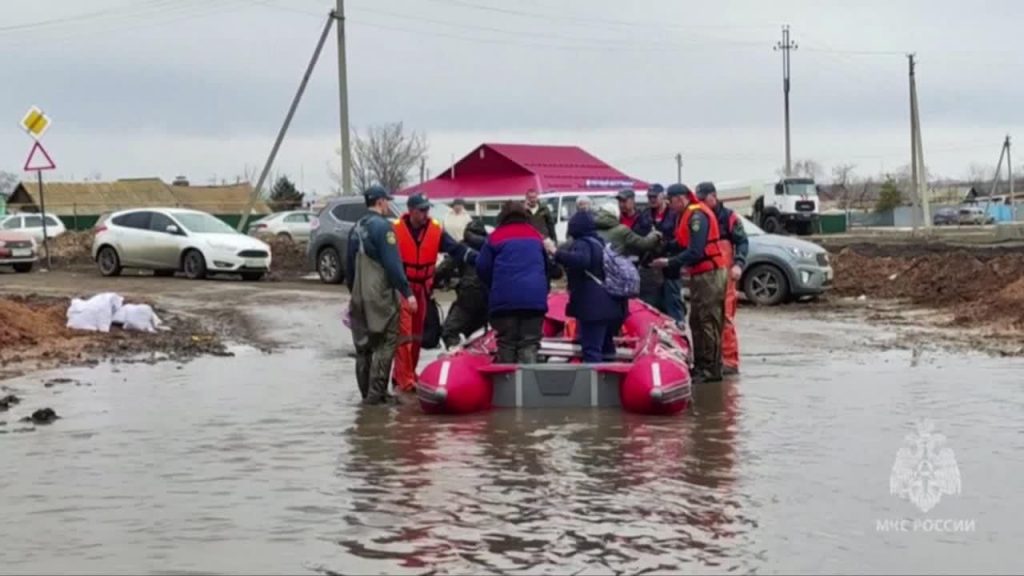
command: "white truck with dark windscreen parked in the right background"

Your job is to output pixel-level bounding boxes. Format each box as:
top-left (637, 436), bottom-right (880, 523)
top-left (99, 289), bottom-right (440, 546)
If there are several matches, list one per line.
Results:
top-left (715, 177), bottom-right (821, 236)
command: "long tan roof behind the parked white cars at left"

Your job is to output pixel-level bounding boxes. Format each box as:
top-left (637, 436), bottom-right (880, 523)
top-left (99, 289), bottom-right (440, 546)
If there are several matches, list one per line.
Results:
top-left (8, 178), bottom-right (270, 215)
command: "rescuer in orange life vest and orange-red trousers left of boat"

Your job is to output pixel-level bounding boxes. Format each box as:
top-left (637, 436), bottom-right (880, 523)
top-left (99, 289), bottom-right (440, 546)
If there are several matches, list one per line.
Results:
top-left (393, 194), bottom-right (476, 392)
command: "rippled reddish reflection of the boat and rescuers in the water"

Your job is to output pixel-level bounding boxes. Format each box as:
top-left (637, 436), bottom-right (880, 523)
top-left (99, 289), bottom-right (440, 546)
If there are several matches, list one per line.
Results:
top-left (336, 382), bottom-right (756, 573)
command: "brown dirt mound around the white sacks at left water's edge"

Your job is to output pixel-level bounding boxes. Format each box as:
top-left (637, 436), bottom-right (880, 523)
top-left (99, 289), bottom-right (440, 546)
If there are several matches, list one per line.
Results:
top-left (0, 295), bottom-right (230, 377)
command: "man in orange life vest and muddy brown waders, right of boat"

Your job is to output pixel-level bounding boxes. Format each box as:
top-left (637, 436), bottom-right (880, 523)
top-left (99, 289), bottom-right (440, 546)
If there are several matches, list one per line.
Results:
top-left (650, 183), bottom-right (727, 382)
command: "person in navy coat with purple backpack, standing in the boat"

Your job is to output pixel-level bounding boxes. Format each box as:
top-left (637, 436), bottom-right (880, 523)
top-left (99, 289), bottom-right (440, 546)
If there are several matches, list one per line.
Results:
top-left (555, 208), bottom-right (627, 363)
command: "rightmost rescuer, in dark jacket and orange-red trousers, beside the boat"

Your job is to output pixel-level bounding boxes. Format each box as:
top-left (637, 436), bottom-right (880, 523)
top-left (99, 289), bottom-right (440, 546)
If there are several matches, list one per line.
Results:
top-left (696, 182), bottom-right (749, 375)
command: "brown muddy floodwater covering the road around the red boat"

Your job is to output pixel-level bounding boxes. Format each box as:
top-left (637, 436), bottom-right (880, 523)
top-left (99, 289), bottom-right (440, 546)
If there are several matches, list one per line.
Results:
top-left (0, 302), bottom-right (1024, 574)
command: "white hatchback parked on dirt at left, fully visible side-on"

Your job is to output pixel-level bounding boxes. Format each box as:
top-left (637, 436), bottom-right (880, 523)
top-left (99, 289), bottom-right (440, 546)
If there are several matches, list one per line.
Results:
top-left (92, 208), bottom-right (270, 281)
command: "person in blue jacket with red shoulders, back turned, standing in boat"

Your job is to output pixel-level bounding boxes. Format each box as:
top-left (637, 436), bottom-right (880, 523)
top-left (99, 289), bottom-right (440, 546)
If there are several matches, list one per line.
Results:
top-left (476, 201), bottom-right (551, 364)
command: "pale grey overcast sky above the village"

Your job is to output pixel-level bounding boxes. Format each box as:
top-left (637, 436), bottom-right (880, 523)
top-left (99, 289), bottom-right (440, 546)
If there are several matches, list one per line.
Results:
top-left (0, 0), bottom-right (1024, 194)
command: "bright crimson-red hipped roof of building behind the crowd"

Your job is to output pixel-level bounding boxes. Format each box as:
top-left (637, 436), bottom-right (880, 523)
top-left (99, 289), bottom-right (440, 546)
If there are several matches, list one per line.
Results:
top-left (398, 143), bottom-right (647, 199)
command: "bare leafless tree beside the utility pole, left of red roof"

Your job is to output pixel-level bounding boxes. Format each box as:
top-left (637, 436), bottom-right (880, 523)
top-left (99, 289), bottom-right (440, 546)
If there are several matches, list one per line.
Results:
top-left (331, 122), bottom-right (427, 194)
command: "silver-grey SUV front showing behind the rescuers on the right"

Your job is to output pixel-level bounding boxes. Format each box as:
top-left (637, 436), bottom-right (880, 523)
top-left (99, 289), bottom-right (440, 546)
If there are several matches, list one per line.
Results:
top-left (739, 216), bottom-right (834, 306)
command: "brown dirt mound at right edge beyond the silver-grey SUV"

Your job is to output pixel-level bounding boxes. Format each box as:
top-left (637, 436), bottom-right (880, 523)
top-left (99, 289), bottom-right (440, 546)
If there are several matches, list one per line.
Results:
top-left (833, 247), bottom-right (1024, 329)
